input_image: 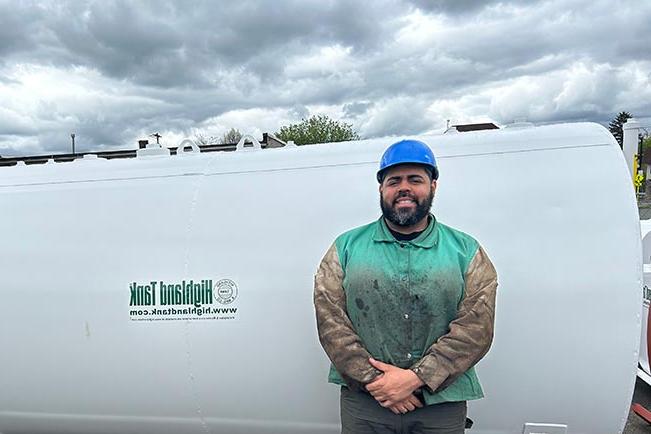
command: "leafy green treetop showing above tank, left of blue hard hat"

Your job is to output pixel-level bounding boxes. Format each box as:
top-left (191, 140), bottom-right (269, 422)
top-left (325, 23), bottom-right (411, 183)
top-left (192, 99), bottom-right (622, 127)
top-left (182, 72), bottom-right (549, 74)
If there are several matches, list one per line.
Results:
top-left (276, 115), bottom-right (359, 145)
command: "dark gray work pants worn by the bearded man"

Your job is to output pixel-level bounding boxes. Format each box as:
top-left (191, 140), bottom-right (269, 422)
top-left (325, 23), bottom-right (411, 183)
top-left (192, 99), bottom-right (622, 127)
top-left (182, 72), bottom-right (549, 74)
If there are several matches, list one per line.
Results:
top-left (340, 387), bottom-right (466, 434)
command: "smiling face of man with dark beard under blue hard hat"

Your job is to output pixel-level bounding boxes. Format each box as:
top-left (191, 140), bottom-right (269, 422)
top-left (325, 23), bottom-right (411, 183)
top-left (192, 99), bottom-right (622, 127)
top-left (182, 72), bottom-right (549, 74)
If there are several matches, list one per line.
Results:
top-left (380, 164), bottom-right (436, 227)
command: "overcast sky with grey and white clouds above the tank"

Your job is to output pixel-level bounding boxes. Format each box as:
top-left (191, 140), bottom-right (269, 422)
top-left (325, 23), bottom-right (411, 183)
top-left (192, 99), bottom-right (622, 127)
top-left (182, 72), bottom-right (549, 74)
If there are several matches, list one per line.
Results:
top-left (0, 0), bottom-right (651, 156)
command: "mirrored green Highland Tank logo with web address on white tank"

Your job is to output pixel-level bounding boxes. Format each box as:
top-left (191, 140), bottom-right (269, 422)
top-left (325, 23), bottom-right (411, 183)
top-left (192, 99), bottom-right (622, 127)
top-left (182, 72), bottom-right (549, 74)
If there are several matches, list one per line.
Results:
top-left (128, 279), bottom-right (238, 321)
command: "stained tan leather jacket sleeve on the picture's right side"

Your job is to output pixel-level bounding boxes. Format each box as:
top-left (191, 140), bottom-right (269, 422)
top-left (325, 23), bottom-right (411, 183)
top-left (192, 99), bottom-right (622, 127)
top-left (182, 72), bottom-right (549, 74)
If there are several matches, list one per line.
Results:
top-left (411, 247), bottom-right (497, 392)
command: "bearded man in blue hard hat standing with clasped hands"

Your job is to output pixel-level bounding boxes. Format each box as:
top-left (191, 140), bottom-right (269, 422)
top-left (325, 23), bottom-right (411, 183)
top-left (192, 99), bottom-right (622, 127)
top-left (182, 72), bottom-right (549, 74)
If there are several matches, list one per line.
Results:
top-left (314, 140), bottom-right (497, 434)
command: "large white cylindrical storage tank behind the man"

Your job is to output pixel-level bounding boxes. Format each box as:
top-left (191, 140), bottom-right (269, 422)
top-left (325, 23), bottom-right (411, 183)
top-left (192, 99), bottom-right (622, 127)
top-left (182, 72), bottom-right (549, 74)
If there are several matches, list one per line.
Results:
top-left (0, 124), bottom-right (642, 434)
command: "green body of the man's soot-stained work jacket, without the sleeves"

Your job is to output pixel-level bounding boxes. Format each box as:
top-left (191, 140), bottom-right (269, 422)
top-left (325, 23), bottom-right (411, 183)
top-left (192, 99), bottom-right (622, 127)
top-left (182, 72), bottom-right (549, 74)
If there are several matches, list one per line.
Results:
top-left (328, 216), bottom-right (484, 405)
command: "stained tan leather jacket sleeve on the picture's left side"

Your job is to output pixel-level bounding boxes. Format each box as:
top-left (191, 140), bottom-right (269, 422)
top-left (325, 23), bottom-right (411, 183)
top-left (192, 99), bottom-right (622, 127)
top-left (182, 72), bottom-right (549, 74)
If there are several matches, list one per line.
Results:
top-left (314, 244), bottom-right (380, 389)
